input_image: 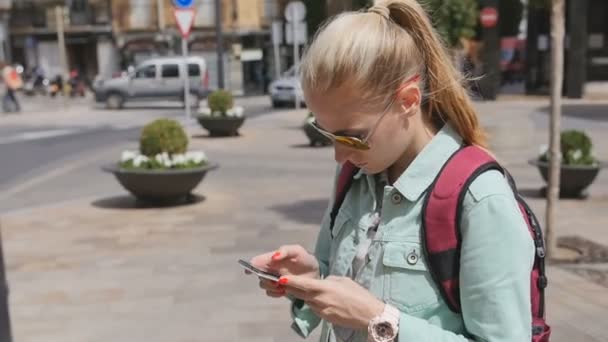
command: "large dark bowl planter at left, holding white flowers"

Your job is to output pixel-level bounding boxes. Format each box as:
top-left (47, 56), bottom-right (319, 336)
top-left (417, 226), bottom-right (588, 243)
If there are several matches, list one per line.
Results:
top-left (102, 164), bottom-right (218, 203)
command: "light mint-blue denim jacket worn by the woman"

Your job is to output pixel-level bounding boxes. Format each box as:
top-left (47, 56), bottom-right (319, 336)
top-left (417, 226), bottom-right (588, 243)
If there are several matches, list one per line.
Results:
top-left (292, 125), bottom-right (534, 342)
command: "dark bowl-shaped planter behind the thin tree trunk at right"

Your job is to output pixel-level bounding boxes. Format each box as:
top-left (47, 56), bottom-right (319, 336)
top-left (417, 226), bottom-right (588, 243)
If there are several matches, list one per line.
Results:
top-left (528, 159), bottom-right (604, 198)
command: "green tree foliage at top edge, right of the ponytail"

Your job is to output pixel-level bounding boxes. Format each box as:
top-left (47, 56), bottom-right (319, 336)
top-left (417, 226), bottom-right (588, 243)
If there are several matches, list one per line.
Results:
top-left (419, 0), bottom-right (479, 48)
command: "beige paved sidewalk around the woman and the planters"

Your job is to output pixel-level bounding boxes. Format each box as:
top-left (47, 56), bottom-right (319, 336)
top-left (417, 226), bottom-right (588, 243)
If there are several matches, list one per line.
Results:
top-left (0, 98), bottom-right (608, 342)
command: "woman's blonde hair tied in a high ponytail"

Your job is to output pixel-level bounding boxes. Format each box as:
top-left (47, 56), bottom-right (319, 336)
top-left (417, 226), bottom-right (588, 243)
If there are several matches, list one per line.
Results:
top-left (300, 0), bottom-right (486, 146)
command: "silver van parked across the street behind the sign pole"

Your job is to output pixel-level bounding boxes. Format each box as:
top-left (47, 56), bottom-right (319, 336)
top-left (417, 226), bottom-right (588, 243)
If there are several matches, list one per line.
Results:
top-left (94, 57), bottom-right (209, 109)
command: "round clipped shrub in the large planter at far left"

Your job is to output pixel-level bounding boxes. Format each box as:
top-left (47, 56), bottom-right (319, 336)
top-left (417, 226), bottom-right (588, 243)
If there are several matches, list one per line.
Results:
top-left (139, 119), bottom-right (188, 157)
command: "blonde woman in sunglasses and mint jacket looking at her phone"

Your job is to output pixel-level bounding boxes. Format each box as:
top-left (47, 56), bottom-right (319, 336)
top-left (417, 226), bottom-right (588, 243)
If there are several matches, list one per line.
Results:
top-left (251, 0), bottom-right (534, 342)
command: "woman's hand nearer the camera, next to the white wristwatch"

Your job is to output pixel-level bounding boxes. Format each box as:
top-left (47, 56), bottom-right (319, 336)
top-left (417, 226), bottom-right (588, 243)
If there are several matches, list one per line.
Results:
top-left (279, 276), bottom-right (385, 330)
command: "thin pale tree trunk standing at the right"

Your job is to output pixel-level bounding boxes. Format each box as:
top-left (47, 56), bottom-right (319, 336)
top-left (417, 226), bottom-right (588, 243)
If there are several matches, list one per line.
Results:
top-left (545, 0), bottom-right (565, 259)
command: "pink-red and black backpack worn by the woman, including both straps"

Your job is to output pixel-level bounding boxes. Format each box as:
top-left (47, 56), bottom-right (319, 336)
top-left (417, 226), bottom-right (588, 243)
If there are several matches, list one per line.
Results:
top-left (330, 146), bottom-right (551, 342)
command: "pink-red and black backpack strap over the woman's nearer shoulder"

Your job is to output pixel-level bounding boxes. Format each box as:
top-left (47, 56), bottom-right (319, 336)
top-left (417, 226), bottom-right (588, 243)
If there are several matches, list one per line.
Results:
top-left (422, 146), bottom-right (503, 313)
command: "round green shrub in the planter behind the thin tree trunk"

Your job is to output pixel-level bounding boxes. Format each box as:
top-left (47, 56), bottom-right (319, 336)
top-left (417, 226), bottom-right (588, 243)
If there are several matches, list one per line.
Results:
top-left (539, 130), bottom-right (597, 165)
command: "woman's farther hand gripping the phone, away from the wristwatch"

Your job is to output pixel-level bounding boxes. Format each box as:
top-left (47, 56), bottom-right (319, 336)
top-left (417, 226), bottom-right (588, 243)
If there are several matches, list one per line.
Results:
top-left (246, 245), bottom-right (319, 298)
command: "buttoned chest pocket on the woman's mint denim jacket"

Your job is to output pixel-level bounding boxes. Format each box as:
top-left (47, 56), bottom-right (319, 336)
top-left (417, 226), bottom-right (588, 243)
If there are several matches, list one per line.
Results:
top-left (382, 242), bottom-right (439, 312)
